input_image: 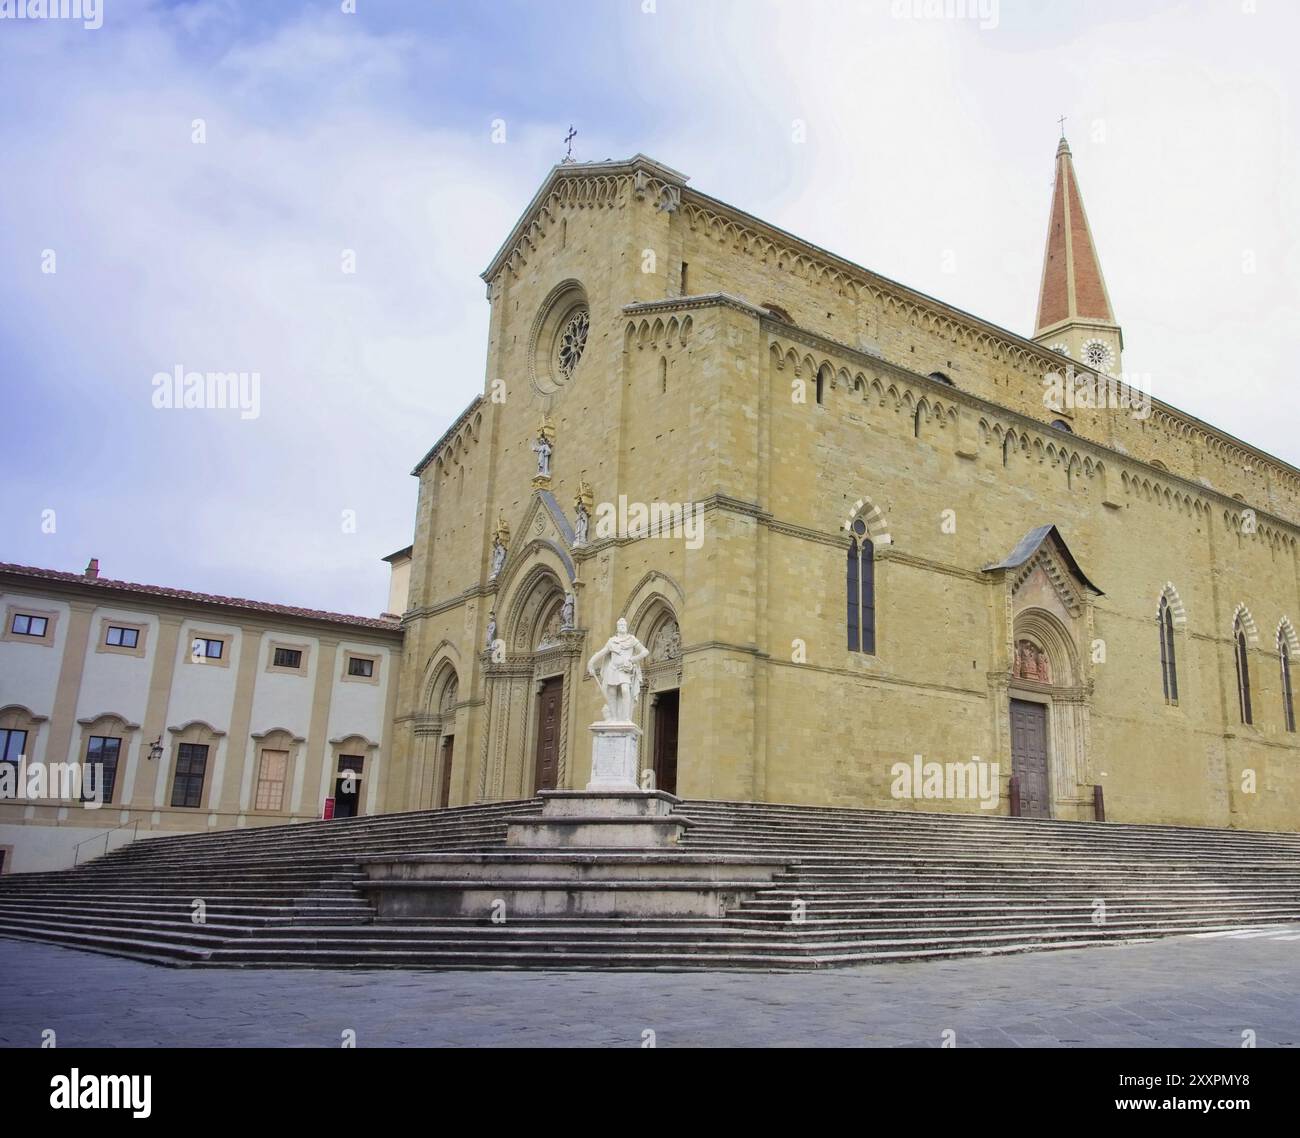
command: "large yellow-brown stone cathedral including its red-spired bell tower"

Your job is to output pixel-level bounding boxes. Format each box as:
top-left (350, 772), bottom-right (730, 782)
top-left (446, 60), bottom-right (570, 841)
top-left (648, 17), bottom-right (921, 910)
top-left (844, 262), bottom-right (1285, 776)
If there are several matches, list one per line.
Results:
top-left (385, 146), bottom-right (1300, 828)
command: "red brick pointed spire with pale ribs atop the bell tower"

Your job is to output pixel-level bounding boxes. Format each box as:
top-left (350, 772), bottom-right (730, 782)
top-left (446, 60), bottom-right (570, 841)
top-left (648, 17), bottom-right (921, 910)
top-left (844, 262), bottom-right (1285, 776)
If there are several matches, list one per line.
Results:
top-left (1034, 135), bottom-right (1115, 338)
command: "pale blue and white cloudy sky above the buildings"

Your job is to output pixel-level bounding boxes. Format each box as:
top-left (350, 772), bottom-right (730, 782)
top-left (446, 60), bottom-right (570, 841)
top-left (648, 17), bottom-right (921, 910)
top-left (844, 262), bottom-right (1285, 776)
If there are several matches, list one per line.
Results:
top-left (0, 0), bottom-right (1300, 615)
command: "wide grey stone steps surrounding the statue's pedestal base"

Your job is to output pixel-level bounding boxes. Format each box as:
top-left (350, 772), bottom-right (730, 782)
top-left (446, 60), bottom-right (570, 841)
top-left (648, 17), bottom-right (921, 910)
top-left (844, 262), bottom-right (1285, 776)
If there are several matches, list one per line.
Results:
top-left (0, 801), bottom-right (1300, 969)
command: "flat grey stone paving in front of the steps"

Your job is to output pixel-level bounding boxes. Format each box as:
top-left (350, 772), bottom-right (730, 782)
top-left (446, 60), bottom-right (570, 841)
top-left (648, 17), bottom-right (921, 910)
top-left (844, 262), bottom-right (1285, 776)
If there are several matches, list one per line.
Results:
top-left (0, 927), bottom-right (1300, 1047)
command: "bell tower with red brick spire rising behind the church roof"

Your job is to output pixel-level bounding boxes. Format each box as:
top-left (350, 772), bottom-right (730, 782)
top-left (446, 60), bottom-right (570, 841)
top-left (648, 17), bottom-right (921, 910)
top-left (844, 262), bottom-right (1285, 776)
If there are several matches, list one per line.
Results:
top-left (1034, 134), bottom-right (1125, 376)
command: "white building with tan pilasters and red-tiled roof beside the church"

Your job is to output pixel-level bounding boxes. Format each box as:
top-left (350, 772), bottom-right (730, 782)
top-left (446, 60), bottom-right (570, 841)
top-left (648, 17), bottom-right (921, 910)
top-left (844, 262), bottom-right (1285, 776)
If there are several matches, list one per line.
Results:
top-left (0, 562), bottom-right (402, 871)
